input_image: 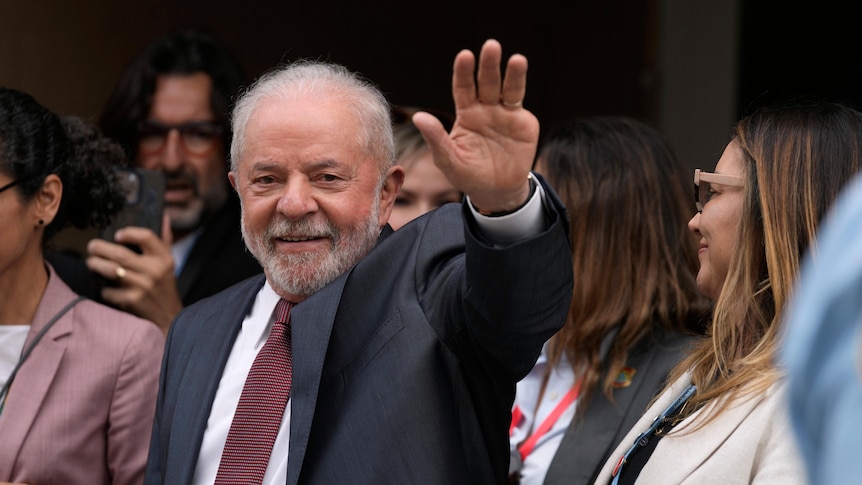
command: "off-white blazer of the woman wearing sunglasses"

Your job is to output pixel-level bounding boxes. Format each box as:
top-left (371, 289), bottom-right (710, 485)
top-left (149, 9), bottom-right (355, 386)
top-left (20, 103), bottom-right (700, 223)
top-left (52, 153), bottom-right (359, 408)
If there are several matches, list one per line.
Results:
top-left (595, 374), bottom-right (807, 485)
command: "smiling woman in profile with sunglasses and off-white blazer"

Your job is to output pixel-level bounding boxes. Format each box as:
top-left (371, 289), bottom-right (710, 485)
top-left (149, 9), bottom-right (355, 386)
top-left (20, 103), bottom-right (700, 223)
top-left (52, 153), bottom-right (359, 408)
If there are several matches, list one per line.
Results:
top-left (596, 102), bottom-right (862, 484)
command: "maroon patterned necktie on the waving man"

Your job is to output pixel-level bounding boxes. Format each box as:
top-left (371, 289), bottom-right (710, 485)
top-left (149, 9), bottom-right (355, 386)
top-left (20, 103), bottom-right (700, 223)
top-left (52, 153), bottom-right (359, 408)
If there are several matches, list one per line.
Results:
top-left (215, 299), bottom-right (293, 485)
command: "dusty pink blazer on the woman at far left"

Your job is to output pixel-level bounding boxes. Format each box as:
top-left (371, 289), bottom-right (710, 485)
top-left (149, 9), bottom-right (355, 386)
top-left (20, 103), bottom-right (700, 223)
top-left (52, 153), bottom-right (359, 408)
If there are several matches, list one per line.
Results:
top-left (0, 266), bottom-right (164, 485)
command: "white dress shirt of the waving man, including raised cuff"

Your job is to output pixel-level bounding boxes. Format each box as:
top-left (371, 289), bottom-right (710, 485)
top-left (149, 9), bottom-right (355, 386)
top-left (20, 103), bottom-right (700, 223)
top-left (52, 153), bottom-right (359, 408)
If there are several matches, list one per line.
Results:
top-left (193, 177), bottom-right (545, 485)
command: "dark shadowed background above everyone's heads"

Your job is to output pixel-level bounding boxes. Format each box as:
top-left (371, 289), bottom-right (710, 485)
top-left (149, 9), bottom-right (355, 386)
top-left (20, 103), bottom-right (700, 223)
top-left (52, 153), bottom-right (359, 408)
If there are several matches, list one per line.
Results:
top-left (0, 0), bottom-right (862, 195)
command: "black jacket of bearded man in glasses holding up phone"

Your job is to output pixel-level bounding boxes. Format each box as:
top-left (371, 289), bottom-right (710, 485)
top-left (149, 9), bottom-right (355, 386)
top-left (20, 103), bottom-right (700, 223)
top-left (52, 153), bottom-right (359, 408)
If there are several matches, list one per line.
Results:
top-left (46, 194), bottom-right (262, 306)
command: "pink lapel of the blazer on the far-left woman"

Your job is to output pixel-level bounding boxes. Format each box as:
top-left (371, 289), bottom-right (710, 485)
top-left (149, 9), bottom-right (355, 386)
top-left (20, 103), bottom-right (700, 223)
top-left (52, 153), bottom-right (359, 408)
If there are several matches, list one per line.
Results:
top-left (0, 272), bottom-right (76, 476)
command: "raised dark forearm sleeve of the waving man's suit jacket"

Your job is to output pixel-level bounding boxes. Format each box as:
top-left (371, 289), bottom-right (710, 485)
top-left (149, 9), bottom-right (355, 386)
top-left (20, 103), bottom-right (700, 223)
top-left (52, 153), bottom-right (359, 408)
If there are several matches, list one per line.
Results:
top-left (463, 172), bottom-right (573, 381)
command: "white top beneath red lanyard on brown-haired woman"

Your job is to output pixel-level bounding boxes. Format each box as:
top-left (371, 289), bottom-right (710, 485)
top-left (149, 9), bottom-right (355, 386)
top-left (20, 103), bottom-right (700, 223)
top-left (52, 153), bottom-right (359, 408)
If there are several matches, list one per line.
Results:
top-left (509, 343), bottom-right (578, 485)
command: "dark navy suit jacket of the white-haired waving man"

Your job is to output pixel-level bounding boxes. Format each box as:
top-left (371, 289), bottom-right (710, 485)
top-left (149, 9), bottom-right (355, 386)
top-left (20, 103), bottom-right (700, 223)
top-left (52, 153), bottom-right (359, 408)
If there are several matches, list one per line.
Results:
top-left (145, 182), bottom-right (572, 485)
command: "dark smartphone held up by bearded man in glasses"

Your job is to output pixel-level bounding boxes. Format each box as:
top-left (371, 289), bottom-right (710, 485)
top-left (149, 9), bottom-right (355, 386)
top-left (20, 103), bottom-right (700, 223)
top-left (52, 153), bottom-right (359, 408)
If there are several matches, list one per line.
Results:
top-left (101, 167), bottom-right (166, 253)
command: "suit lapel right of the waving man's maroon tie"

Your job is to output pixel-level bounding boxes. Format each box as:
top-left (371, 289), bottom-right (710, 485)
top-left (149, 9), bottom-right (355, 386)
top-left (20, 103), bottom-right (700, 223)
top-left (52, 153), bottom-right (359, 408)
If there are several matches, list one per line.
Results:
top-left (287, 272), bottom-right (350, 485)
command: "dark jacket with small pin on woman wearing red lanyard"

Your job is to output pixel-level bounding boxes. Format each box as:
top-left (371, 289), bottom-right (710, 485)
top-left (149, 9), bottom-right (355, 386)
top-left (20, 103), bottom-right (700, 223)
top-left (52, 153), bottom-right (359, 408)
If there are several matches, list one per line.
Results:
top-left (544, 329), bottom-right (695, 485)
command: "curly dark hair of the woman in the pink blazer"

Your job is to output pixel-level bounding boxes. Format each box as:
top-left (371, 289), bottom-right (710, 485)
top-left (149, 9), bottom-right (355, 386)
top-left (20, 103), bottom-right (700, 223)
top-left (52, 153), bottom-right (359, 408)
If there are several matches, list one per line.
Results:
top-left (0, 88), bottom-right (127, 245)
